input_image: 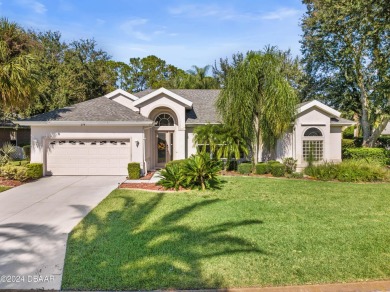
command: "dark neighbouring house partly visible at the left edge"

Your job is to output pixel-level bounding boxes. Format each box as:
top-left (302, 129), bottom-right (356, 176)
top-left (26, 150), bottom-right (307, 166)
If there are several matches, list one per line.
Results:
top-left (0, 120), bottom-right (31, 147)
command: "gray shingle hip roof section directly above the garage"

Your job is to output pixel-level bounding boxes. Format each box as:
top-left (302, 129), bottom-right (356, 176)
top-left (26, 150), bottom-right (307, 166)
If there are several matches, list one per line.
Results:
top-left (22, 96), bottom-right (151, 122)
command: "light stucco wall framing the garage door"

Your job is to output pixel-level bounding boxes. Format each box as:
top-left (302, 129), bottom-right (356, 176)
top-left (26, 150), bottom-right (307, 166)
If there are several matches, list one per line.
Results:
top-left (31, 126), bottom-right (144, 173)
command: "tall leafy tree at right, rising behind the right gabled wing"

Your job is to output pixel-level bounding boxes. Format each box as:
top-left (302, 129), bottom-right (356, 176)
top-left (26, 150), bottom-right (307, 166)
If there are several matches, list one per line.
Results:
top-left (302, 0), bottom-right (390, 147)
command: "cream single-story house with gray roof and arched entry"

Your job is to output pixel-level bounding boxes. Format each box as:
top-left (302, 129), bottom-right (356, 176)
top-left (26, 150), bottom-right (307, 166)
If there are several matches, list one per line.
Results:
top-left (18, 88), bottom-right (354, 175)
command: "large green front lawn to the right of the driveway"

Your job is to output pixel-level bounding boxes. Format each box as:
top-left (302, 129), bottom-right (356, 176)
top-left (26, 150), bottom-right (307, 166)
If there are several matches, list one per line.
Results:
top-left (62, 177), bottom-right (390, 290)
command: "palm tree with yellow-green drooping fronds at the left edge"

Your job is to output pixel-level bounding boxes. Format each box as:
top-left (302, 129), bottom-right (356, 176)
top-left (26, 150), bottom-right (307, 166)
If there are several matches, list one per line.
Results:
top-left (0, 18), bottom-right (39, 113)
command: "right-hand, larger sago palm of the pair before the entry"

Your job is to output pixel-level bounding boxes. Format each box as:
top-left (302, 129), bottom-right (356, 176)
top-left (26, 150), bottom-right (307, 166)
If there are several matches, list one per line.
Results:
top-left (182, 153), bottom-right (222, 191)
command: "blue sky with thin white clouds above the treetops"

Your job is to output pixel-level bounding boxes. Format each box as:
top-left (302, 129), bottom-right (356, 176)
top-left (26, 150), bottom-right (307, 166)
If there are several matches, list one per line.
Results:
top-left (0, 0), bottom-right (305, 70)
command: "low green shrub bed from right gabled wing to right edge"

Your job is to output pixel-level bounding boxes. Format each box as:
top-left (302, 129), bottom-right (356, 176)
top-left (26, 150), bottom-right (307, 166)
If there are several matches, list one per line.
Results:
top-left (305, 160), bottom-right (390, 182)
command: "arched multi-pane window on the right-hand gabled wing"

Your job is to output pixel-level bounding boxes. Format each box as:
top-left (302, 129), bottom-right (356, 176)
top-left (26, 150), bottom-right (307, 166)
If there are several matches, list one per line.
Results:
top-left (302, 127), bottom-right (324, 161)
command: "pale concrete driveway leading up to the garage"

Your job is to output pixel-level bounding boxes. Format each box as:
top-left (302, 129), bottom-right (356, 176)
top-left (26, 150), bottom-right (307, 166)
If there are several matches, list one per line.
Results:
top-left (0, 176), bottom-right (125, 290)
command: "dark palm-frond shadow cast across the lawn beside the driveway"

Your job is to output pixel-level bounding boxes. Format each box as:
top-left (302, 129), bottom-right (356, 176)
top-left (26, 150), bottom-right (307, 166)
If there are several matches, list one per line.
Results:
top-left (62, 194), bottom-right (264, 290)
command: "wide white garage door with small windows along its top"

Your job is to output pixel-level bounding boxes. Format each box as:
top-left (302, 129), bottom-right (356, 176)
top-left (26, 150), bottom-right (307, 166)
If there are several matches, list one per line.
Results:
top-left (46, 139), bottom-right (131, 175)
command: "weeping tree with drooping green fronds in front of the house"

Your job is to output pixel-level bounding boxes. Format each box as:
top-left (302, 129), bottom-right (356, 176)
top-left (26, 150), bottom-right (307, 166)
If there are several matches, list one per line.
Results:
top-left (216, 47), bottom-right (297, 163)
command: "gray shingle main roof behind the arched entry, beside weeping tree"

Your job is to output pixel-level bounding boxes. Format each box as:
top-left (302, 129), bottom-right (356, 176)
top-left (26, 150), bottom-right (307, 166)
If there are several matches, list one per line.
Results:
top-left (134, 89), bottom-right (221, 124)
